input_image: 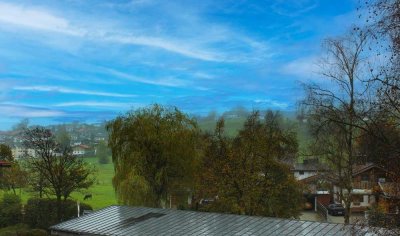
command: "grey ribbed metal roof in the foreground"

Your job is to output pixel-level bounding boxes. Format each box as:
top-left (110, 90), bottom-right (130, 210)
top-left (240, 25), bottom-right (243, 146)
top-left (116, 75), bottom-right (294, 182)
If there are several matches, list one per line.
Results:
top-left (50, 206), bottom-right (372, 236)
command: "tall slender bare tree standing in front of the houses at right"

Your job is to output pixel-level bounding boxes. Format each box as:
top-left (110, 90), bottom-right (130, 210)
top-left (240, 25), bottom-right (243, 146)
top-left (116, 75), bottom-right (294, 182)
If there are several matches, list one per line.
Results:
top-left (302, 31), bottom-right (371, 224)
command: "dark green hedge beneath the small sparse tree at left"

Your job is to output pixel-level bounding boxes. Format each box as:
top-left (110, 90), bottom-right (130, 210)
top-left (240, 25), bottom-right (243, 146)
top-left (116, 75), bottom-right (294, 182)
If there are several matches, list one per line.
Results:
top-left (25, 198), bottom-right (93, 230)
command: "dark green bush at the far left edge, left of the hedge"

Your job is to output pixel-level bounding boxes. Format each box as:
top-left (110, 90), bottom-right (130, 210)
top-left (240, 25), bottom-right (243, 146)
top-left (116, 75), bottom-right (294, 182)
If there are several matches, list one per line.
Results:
top-left (0, 193), bottom-right (22, 228)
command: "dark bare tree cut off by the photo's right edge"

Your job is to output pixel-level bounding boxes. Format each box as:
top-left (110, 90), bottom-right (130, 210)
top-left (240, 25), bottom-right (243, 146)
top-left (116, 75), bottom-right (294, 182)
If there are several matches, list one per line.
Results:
top-left (350, 0), bottom-right (400, 232)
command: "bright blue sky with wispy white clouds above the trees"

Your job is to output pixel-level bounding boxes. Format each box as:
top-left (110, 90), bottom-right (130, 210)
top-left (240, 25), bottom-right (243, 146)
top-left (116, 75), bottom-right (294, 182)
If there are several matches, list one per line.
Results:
top-left (0, 0), bottom-right (358, 130)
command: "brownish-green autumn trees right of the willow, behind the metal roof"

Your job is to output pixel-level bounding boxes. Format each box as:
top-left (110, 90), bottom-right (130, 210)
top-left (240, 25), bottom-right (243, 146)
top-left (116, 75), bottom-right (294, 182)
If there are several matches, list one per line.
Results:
top-left (198, 112), bottom-right (303, 217)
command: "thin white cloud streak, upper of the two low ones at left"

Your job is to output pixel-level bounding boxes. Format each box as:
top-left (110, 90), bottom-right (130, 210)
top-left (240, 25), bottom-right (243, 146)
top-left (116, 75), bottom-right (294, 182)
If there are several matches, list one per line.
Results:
top-left (13, 86), bottom-right (136, 98)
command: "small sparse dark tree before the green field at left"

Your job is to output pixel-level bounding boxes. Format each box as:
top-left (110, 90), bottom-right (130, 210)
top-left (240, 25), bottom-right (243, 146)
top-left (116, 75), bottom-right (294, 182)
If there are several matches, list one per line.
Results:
top-left (24, 127), bottom-right (94, 220)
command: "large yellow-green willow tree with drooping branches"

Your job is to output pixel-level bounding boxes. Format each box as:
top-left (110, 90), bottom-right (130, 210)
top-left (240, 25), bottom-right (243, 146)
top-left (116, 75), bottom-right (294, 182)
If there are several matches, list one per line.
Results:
top-left (107, 105), bottom-right (199, 207)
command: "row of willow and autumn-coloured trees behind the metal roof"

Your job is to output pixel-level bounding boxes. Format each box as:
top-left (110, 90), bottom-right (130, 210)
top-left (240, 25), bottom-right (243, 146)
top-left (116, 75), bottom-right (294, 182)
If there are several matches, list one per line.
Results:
top-left (107, 105), bottom-right (302, 217)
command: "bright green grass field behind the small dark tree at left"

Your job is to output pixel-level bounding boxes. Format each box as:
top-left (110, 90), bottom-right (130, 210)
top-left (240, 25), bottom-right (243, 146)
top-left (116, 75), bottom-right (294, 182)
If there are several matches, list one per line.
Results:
top-left (0, 157), bottom-right (117, 209)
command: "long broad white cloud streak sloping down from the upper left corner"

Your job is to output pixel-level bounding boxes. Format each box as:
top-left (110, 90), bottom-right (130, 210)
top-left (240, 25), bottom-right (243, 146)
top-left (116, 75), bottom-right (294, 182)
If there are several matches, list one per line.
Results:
top-left (0, 2), bottom-right (247, 62)
